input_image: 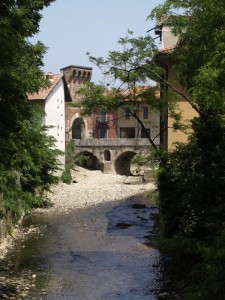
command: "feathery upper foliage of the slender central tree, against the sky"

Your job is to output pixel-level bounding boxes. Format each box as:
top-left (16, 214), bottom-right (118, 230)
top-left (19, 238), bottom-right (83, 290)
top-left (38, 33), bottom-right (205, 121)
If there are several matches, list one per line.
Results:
top-left (89, 30), bottom-right (157, 88)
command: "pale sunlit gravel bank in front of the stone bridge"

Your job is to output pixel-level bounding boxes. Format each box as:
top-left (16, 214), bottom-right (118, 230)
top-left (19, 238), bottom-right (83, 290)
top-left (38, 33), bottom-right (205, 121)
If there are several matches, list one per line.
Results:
top-left (48, 168), bottom-right (155, 213)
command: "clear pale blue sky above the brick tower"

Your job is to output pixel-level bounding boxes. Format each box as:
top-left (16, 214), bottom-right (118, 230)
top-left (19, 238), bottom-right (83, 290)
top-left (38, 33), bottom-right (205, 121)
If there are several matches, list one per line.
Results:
top-left (35, 0), bottom-right (164, 82)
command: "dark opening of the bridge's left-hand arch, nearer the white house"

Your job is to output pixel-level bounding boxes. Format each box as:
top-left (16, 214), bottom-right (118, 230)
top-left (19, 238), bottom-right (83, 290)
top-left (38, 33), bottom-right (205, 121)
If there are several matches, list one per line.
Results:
top-left (75, 151), bottom-right (101, 170)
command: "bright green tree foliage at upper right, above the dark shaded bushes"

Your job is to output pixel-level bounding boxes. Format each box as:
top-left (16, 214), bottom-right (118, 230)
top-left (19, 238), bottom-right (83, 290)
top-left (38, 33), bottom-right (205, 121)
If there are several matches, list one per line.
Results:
top-left (150, 0), bottom-right (225, 114)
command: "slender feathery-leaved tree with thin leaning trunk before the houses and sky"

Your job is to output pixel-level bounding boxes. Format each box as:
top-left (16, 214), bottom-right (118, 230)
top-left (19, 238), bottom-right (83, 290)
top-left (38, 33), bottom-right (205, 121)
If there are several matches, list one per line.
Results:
top-left (76, 30), bottom-right (184, 164)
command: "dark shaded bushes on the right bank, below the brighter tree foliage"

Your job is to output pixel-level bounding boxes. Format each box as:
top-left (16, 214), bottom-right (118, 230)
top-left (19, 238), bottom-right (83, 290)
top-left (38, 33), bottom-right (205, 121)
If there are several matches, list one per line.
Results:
top-left (158, 120), bottom-right (225, 300)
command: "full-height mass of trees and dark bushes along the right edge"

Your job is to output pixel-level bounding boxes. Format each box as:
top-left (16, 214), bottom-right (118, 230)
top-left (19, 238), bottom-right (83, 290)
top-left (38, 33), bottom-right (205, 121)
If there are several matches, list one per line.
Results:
top-left (151, 0), bottom-right (225, 300)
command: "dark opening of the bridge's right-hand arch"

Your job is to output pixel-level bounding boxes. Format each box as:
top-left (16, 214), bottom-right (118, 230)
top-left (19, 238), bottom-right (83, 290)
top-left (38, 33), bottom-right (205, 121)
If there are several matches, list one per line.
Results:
top-left (114, 151), bottom-right (136, 176)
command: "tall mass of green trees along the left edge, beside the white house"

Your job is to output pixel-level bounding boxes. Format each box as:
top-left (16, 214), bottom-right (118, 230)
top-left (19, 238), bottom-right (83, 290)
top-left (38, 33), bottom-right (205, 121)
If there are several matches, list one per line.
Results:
top-left (0, 0), bottom-right (59, 218)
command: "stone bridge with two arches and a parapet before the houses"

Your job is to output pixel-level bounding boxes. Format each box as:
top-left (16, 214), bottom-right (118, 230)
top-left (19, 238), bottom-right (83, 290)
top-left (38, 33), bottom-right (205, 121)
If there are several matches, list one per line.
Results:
top-left (73, 138), bottom-right (159, 176)
